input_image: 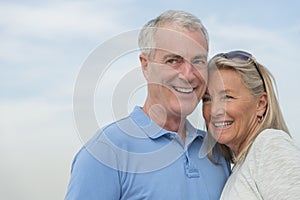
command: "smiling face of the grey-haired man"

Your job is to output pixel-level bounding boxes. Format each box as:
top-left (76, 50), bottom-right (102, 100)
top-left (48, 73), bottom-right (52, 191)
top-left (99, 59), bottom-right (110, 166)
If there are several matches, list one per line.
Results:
top-left (143, 27), bottom-right (207, 117)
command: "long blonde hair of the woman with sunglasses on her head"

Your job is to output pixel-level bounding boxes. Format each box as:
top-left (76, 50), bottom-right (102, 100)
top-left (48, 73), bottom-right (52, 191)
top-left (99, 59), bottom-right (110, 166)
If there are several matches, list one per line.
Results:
top-left (208, 52), bottom-right (289, 163)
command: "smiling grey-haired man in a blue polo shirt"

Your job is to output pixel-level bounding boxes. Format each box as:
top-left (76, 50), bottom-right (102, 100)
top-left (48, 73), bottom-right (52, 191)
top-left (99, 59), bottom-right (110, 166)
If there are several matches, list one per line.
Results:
top-left (66, 11), bottom-right (229, 200)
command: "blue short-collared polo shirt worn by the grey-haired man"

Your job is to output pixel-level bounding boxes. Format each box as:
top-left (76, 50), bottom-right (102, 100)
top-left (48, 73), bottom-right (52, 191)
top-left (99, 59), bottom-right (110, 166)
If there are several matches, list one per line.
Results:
top-left (65, 107), bottom-right (229, 200)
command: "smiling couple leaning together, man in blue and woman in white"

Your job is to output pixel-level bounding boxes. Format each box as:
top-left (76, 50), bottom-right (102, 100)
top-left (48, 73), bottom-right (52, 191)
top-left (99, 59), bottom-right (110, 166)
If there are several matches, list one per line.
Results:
top-left (65, 11), bottom-right (300, 200)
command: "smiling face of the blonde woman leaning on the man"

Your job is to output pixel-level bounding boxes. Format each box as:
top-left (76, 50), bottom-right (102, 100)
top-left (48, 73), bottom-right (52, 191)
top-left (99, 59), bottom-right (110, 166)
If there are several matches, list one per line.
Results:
top-left (203, 69), bottom-right (259, 155)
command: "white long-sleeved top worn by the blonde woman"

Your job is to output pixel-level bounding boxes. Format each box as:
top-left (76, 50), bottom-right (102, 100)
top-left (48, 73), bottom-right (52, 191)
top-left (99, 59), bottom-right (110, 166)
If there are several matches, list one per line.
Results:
top-left (221, 129), bottom-right (300, 200)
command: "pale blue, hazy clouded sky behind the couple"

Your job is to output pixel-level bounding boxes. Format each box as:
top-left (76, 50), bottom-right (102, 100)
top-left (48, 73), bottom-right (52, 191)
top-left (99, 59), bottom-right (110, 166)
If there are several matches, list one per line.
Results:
top-left (0, 0), bottom-right (300, 200)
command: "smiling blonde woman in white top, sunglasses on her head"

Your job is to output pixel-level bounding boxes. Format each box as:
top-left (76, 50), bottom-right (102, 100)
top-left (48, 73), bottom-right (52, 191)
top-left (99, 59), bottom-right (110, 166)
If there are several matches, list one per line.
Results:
top-left (203, 51), bottom-right (300, 200)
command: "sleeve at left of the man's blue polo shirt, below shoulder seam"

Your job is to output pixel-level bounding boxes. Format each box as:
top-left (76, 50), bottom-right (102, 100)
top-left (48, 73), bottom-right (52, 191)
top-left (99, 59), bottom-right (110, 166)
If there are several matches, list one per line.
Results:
top-left (65, 148), bottom-right (120, 200)
